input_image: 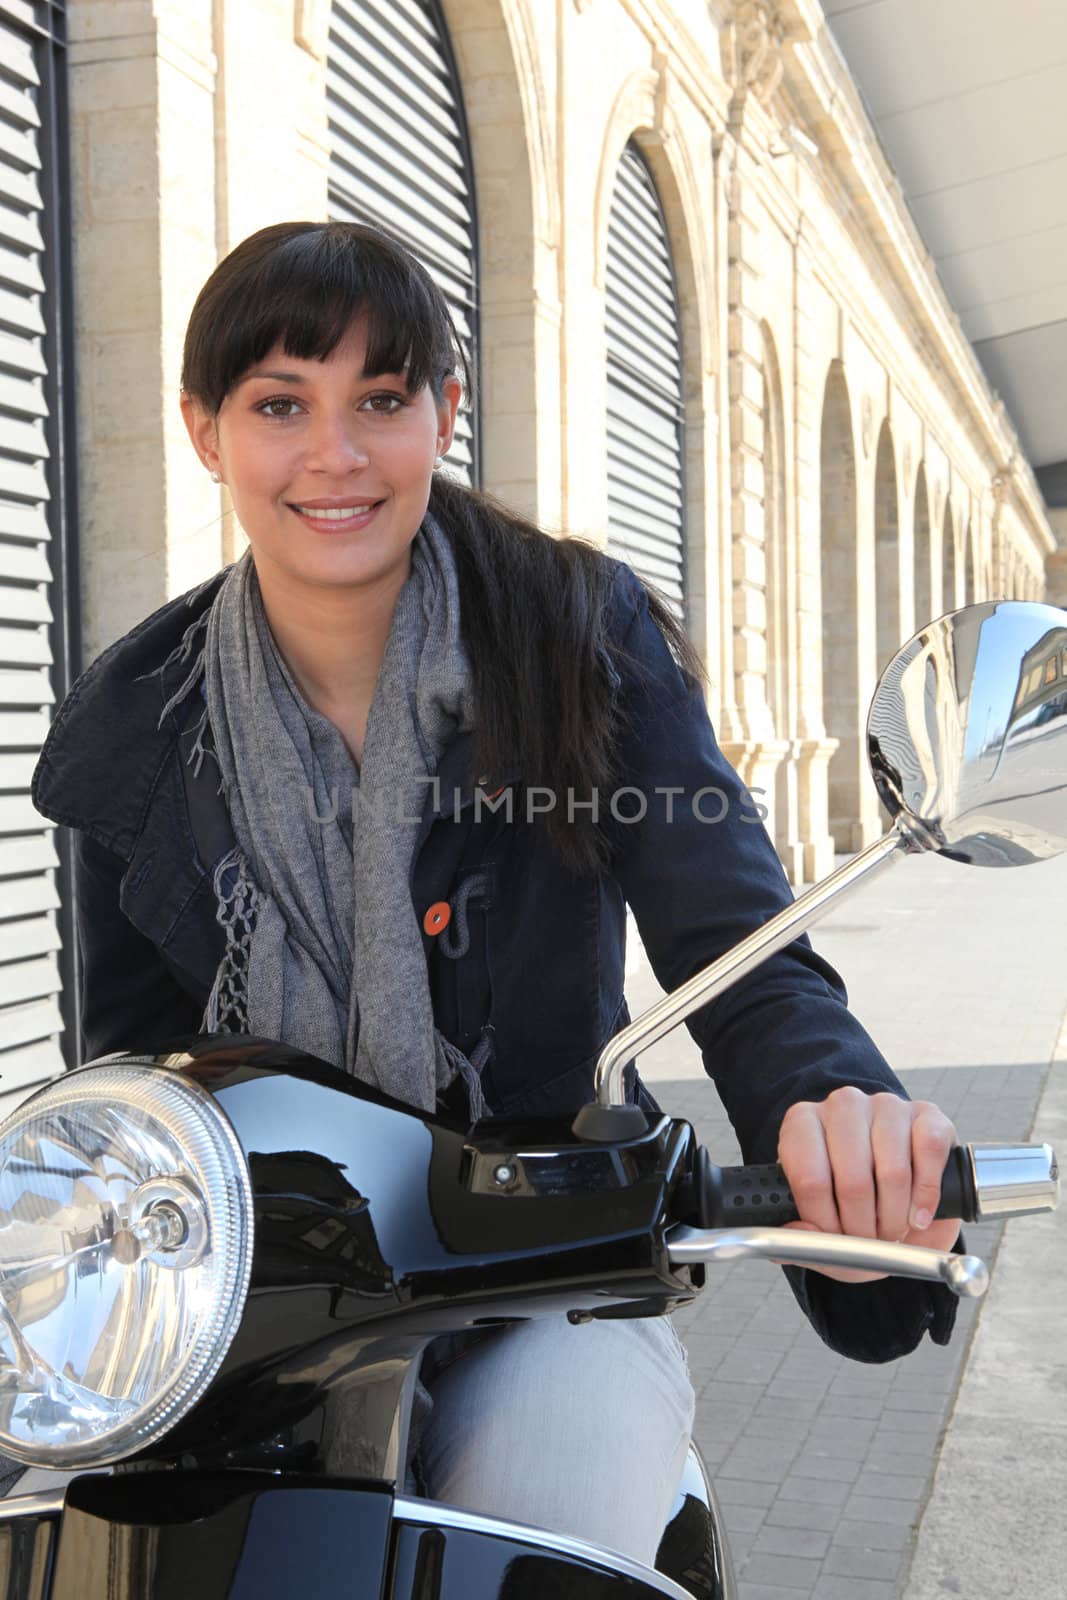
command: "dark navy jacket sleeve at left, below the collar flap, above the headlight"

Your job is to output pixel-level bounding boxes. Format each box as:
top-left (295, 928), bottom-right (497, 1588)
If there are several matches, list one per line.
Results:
top-left (74, 829), bottom-right (202, 1061)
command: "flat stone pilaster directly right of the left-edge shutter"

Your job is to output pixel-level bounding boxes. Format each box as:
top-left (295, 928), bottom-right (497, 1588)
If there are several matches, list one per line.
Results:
top-left (67, 0), bottom-right (219, 662)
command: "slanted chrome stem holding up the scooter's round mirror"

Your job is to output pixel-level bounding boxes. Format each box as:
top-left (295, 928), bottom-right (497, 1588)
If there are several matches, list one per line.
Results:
top-left (595, 824), bottom-right (923, 1106)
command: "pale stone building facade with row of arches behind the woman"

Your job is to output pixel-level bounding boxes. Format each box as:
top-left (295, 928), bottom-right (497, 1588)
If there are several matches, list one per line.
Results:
top-left (69, 0), bottom-right (1064, 882)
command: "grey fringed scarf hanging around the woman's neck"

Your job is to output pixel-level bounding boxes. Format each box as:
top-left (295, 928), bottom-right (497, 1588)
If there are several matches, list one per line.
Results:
top-left (149, 512), bottom-right (485, 1120)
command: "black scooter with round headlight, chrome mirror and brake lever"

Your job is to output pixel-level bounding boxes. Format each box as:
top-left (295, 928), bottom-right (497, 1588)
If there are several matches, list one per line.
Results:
top-left (0, 603), bottom-right (1067, 1600)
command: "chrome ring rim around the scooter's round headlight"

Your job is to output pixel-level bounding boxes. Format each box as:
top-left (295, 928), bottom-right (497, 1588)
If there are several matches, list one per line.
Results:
top-left (0, 1056), bottom-right (254, 1470)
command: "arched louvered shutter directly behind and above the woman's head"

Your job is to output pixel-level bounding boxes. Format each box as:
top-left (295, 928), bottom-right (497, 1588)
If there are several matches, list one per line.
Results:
top-left (326, 0), bottom-right (478, 483)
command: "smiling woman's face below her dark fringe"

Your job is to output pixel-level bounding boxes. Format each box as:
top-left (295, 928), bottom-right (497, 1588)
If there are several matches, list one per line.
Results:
top-left (181, 318), bottom-right (461, 589)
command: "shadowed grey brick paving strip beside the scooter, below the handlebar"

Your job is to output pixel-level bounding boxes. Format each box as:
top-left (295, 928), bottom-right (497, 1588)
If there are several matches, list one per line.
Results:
top-left (654, 1064), bottom-right (1048, 1600)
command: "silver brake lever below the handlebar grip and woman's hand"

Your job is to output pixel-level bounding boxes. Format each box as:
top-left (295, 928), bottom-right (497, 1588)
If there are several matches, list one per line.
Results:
top-left (665, 1224), bottom-right (989, 1299)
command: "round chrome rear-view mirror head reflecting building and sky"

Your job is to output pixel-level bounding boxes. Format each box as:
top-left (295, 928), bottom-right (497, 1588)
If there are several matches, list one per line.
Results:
top-left (867, 600), bottom-right (1067, 867)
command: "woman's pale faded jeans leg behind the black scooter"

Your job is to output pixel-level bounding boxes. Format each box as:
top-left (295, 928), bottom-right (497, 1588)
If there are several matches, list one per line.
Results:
top-left (419, 1317), bottom-right (696, 1566)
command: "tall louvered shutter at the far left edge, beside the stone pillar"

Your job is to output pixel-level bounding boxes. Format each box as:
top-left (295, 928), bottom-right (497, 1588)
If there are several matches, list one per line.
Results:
top-left (0, 5), bottom-right (64, 1114)
